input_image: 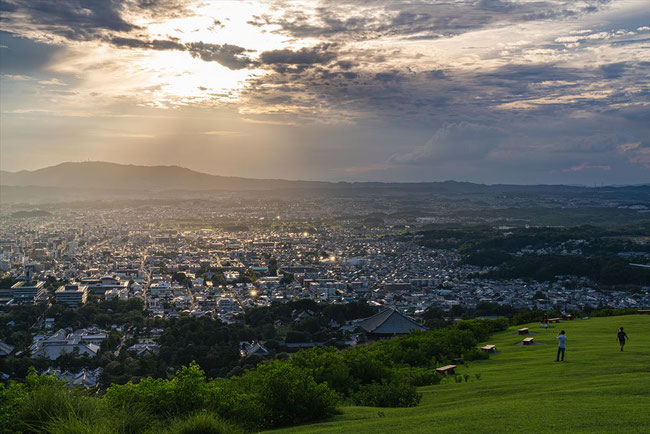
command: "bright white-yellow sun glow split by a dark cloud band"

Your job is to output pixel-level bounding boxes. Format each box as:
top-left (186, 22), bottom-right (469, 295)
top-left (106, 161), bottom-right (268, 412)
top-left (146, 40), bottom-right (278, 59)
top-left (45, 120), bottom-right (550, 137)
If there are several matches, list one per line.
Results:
top-left (39, 2), bottom-right (292, 108)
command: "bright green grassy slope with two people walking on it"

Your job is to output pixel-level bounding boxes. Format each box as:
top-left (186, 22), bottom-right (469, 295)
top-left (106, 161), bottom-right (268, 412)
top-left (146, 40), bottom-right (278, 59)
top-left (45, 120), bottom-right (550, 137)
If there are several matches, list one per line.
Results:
top-left (274, 315), bottom-right (650, 434)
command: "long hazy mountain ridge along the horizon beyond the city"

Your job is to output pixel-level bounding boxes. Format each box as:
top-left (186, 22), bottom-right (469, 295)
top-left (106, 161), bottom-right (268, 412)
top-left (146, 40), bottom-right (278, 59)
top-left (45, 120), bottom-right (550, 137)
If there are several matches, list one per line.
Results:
top-left (0, 161), bottom-right (650, 194)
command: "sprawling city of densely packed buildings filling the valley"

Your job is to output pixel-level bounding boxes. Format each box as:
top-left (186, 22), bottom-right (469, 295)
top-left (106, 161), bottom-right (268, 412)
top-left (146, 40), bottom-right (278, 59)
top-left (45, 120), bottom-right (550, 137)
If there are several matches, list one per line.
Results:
top-left (0, 188), bottom-right (650, 387)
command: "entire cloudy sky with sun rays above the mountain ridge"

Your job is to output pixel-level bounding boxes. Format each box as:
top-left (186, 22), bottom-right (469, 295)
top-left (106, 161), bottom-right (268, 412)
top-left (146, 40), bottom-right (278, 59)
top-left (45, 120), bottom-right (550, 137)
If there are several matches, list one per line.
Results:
top-left (0, 0), bottom-right (650, 185)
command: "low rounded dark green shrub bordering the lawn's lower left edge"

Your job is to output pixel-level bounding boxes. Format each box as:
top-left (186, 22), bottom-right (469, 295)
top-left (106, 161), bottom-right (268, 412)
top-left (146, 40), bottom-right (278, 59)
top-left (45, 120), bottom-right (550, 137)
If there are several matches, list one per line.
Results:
top-left (351, 381), bottom-right (422, 407)
